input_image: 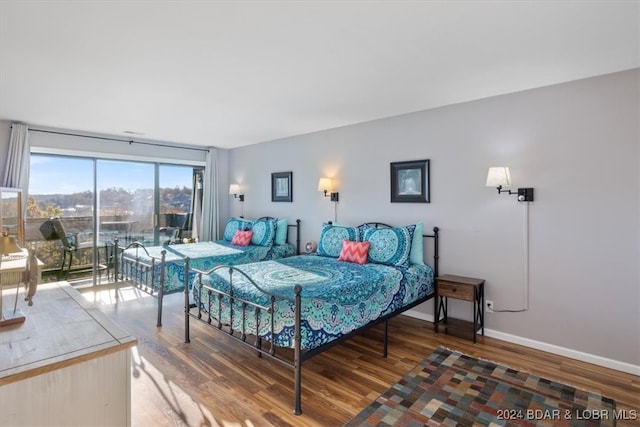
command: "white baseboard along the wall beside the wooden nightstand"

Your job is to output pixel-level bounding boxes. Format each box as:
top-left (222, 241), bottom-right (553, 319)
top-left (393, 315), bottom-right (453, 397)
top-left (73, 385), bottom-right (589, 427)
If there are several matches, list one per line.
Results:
top-left (404, 310), bottom-right (640, 376)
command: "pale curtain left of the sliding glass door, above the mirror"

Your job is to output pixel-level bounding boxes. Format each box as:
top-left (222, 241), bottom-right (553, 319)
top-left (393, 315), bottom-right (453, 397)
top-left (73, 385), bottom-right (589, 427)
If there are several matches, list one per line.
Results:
top-left (2, 123), bottom-right (31, 194)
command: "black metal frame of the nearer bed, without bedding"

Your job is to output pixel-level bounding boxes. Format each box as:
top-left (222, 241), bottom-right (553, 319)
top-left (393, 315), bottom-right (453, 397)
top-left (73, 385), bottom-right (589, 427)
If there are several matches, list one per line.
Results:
top-left (184, 222), bottom-right (439, 415)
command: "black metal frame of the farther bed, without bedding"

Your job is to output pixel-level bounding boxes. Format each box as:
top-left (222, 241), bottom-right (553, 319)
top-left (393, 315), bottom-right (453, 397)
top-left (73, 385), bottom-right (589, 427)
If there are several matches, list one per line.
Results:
top-left (114, 216), bottom-right (300, 327)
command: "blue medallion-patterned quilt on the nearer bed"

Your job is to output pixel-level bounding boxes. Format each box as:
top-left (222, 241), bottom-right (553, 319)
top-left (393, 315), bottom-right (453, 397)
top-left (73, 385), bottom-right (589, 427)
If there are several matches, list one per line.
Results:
top-left (193, 255), bottom-right (434, 350)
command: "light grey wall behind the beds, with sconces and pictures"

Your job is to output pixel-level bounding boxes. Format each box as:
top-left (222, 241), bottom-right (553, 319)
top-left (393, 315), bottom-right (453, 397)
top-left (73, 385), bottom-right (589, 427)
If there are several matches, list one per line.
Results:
top-left (227, 69), bottom-right (640, 366)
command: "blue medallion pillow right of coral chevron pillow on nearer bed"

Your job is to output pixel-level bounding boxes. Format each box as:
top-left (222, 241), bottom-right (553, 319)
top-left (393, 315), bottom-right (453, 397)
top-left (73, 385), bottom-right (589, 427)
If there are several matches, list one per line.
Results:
top-left (363, 224), bottom-right (416, 267)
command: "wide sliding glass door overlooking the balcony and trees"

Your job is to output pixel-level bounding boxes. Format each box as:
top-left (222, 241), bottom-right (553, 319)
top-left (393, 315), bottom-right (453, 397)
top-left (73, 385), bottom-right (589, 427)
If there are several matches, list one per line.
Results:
top-left (26, 154), bottom-right (201, 284)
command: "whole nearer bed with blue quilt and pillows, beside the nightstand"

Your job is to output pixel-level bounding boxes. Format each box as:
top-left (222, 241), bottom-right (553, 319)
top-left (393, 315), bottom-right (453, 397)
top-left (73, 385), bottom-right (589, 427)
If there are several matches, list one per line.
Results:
top-left (183, 223), bottom-right (439, 415)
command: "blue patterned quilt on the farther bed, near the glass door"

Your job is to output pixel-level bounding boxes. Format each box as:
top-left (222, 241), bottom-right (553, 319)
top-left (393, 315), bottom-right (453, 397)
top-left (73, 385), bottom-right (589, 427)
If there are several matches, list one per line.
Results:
top-left (120, 240), bottom-right (295, 294)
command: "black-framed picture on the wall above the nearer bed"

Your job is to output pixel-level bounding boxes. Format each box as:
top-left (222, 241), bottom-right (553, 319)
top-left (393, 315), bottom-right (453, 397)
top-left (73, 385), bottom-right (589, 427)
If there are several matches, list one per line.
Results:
top-left (391, 160), bottom-right (429, 203)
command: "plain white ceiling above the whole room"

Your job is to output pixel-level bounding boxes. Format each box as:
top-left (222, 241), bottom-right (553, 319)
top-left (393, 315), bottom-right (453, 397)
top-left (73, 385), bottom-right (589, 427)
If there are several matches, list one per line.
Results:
top-left (0, 0), bottom-right (640, 148)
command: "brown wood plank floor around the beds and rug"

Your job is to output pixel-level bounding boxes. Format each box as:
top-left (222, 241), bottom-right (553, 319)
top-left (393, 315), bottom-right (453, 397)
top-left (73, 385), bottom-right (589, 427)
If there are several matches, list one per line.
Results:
top-left (83, 288), bottom-right (640, 427)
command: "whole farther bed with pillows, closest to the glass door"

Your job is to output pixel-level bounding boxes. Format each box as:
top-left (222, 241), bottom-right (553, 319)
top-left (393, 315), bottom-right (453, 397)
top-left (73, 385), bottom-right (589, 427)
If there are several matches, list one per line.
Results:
top-left (115, 217), bottom-right (300, 326)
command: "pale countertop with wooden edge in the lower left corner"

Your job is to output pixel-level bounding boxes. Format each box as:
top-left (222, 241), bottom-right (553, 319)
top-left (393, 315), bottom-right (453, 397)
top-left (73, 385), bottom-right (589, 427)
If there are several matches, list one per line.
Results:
top-left (0, 282), bottom-right (138, 386)
